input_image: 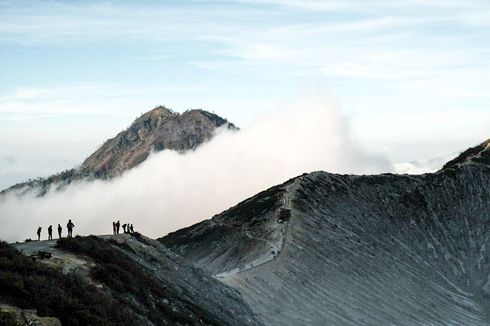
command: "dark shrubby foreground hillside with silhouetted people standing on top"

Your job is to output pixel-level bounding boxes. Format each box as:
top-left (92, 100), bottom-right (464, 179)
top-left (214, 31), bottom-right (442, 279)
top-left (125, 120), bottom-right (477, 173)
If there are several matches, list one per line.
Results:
top-left (0, 234), bottom-right (261, 326)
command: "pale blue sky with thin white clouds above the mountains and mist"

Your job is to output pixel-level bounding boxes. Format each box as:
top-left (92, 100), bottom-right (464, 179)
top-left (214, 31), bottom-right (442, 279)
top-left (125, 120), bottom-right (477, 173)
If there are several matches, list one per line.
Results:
top-left (0, 0), bottom-right (490, 188)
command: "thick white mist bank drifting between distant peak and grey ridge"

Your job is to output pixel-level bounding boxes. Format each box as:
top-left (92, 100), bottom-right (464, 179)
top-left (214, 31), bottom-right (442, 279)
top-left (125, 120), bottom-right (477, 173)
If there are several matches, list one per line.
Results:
top-left (0, 99), bottom-right (393, 242)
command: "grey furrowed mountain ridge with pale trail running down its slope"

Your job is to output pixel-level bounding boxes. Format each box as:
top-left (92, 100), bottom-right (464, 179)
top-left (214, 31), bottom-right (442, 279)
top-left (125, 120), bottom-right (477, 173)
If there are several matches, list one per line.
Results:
top-left (159, 141), bottom-right (490, 325)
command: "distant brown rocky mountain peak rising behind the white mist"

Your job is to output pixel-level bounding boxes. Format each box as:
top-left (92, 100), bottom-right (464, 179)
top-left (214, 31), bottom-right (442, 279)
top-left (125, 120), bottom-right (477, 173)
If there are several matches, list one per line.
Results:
top-left (0, 106), bottom-right (237, 196)
